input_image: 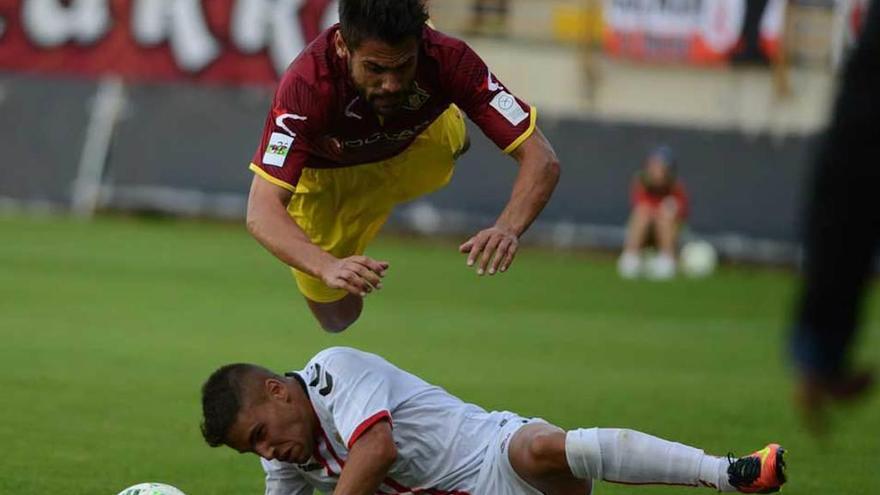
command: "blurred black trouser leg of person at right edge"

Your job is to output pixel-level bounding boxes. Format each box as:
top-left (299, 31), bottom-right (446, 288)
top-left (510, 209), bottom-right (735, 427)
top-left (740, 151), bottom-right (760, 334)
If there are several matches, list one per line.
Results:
top-left (791, 1), bottom-right (880, 378)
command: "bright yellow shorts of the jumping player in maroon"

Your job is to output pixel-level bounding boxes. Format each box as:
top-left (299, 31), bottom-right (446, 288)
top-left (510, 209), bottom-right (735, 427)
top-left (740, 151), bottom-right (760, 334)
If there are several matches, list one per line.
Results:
top-left (287, 105), bottom-right (467, 303)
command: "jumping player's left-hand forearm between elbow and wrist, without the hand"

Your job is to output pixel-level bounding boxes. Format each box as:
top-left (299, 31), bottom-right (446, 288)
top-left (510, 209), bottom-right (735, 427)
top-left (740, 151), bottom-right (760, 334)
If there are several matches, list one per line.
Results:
top-left (247, 205), bottom-right (335, 278)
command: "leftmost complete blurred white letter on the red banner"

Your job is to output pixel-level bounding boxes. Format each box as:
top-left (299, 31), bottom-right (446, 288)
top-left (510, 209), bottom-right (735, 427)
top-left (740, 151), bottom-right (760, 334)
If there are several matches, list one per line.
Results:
top-left (21, 0), bottom-right (111, 48)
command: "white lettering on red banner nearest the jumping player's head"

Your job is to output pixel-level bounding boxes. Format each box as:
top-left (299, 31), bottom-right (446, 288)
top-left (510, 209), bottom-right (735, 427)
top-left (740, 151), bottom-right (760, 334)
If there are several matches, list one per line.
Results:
top-left (230, 0), bottom-right (338, 74)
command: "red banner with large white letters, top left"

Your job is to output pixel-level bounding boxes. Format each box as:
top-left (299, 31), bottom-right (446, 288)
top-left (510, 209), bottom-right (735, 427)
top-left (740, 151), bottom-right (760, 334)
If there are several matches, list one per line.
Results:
top-left (0, 0), bottom-right (338, 84)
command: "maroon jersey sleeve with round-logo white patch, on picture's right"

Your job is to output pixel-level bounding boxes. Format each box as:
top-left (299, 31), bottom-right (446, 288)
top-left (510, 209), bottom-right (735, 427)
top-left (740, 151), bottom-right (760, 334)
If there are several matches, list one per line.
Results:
top-left (448, 44), bottom-right (538, 153)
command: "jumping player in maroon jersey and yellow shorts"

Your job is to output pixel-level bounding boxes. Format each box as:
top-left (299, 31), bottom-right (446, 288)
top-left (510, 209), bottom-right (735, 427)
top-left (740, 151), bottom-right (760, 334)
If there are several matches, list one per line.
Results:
top-left (247, 0), bottom-right (559, 332)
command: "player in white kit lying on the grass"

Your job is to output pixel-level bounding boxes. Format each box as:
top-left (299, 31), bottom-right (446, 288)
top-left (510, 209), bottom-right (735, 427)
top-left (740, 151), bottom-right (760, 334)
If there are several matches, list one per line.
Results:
top-left (202, 347), bottom-right (785, 495)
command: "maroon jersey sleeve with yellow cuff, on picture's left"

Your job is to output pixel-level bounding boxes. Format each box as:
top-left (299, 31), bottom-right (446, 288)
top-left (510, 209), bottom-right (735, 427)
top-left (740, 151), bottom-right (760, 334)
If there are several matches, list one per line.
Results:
top-left (250, 80), bottom-right (324, 192)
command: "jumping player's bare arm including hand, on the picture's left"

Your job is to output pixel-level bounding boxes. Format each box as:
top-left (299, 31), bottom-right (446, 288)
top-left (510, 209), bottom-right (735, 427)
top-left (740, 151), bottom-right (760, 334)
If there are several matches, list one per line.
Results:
top-left (247, 175), bottom-right (389, 297)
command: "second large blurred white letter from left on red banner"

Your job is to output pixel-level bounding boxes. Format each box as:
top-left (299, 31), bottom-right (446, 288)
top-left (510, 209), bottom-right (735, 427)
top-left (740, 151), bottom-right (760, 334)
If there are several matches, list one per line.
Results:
top-left (132, 0), bottom-right (220, 72)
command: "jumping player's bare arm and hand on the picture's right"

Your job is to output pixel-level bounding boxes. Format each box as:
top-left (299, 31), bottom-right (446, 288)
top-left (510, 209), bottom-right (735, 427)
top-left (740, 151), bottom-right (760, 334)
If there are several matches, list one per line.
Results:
top-left (459, 129), bottom-right (560, 275)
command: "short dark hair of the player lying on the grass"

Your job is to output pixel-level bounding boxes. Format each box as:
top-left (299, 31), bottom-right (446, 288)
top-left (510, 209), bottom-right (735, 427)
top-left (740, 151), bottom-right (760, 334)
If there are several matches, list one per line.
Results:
top-left (201, 363), bottom-right (280, 447)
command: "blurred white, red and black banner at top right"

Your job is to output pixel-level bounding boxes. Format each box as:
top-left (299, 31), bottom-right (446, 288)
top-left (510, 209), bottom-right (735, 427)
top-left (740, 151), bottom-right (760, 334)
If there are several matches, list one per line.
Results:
top-left (604, 0), bottom-right (786, 64)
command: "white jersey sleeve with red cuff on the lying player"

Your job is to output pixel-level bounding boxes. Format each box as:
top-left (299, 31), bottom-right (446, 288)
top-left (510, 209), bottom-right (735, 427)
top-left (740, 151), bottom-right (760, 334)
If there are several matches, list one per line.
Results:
top-left (306, 348), bottom-right (398, 449)
